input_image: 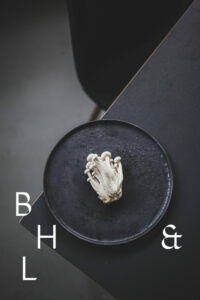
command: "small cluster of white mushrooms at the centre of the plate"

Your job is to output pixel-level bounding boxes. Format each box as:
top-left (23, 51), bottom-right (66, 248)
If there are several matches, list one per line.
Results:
top-left (85, 151), bottom-right (123, 203)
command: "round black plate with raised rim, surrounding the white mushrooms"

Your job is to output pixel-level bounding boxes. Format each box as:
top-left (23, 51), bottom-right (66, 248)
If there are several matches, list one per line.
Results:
top-left (44, 120), bottom-right (173, 245)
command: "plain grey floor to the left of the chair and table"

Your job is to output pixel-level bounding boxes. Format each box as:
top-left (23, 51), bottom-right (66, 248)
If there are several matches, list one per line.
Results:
top-left (0, 0), bottom-right (112, 300)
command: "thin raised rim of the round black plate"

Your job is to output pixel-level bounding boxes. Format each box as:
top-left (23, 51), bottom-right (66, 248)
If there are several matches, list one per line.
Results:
top-left (43, 119), bottom-right (174, 246)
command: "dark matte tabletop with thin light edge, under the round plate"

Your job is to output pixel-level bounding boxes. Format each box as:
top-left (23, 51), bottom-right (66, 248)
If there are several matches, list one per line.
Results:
top-left (21, 0), bottom-right (200, 300)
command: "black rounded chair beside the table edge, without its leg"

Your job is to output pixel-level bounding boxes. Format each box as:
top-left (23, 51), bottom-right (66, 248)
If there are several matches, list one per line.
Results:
top-left (66, 0), bottom-right (192, 109)
